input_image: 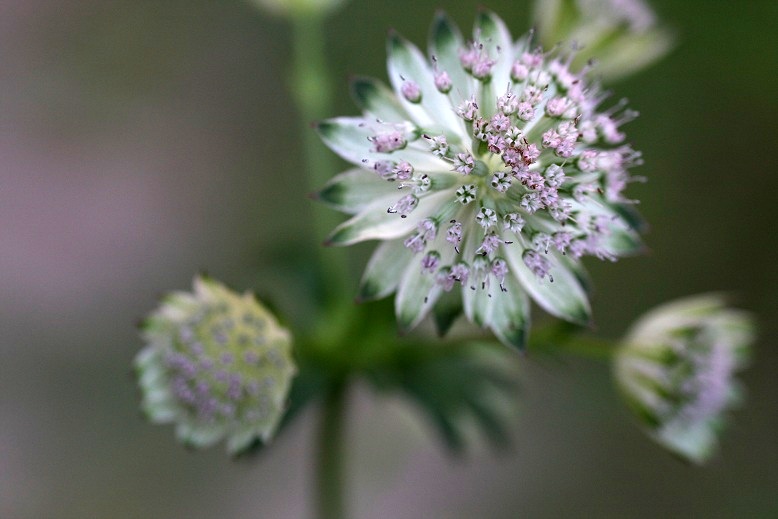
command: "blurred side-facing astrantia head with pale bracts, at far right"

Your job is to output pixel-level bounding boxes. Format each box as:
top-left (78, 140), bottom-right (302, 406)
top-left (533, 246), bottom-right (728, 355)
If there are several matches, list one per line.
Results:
top-left (614, 295), bottom-right (753, 463)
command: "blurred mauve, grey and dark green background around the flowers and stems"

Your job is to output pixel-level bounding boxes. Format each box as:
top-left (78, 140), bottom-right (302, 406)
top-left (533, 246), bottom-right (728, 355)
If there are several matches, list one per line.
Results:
top-left (0, 0), bottom-right (778, 519)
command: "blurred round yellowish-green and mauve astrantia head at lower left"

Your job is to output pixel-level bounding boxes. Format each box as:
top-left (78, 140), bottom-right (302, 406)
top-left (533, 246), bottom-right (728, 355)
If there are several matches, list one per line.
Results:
top-left (135, 277), bottom-right (296, 453)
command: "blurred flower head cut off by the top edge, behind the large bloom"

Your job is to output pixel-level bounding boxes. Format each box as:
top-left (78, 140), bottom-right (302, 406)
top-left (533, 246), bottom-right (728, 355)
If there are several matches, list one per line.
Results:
top-left (535, 0), bottom-right (673, 80)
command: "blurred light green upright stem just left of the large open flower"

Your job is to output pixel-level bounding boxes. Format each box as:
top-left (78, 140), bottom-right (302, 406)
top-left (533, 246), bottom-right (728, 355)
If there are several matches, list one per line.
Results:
top-left (291, 14), bottom-right (349, 302)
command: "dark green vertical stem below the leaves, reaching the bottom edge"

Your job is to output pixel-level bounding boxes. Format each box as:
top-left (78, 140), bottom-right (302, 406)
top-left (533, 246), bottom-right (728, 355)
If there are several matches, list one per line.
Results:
top-left (316, 382), bottom-right (346, 519)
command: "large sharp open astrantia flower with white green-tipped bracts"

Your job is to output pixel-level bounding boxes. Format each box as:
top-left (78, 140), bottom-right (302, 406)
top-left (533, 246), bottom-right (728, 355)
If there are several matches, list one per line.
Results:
top-left (318, 11), bottom-right (640, 347)
